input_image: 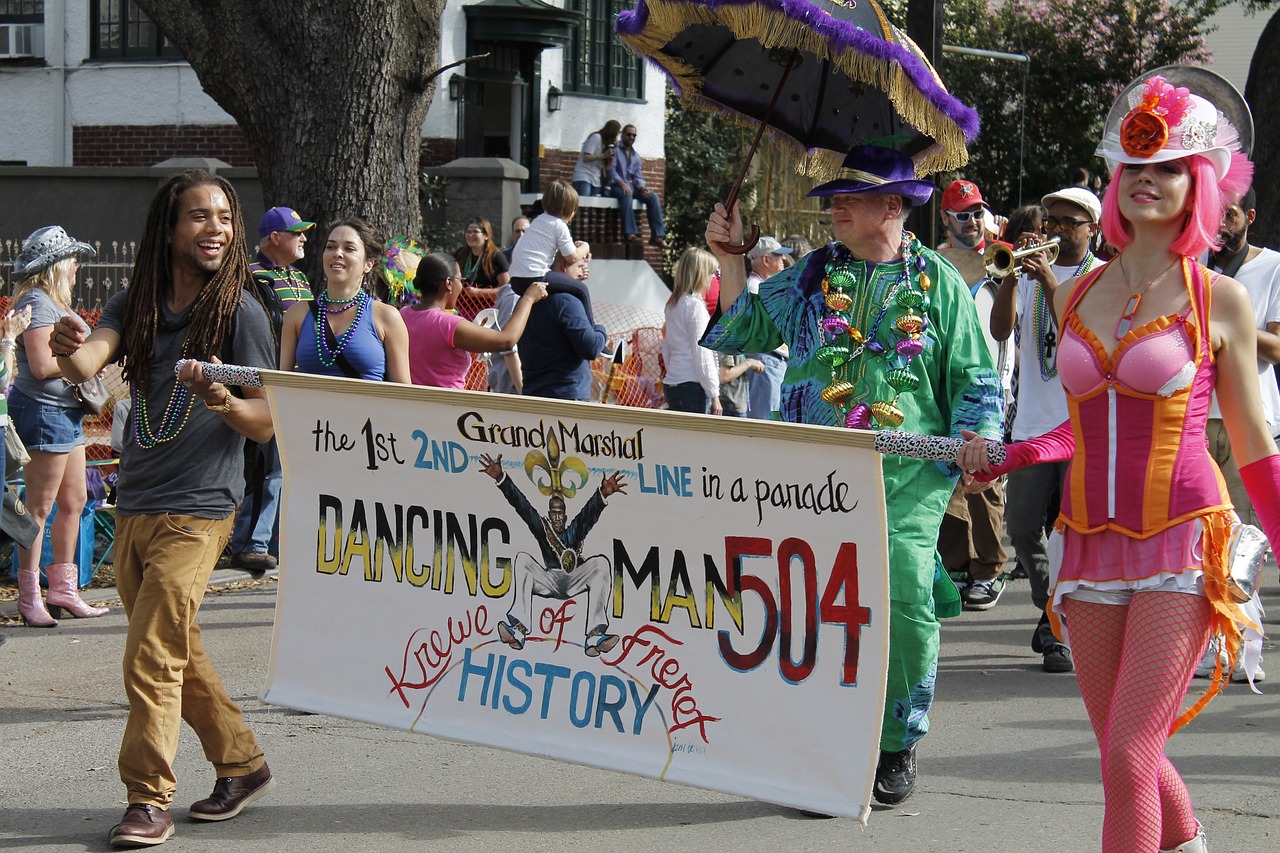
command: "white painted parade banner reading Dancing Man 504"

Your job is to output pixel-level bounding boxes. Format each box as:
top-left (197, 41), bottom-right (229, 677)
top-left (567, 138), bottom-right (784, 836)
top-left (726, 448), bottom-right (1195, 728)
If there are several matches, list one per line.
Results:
top-left (254, 371), bottom-right (888, 822)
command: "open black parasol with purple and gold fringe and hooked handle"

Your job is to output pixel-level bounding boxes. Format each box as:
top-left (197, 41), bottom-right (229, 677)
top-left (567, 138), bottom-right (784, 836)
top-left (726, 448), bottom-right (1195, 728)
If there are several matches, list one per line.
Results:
top-left (617, 0), bottom-right (978, 252)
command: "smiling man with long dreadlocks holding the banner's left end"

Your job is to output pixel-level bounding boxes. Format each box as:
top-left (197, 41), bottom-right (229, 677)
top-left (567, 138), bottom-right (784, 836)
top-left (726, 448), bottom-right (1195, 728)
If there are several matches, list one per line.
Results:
top-left (50, 172), bottom-right (275, 847)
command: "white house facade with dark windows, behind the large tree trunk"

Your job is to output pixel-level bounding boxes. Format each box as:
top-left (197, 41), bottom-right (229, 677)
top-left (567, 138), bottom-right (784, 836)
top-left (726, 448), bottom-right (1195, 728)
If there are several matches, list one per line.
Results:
top-left (0, 0), bottom-right (666, 191)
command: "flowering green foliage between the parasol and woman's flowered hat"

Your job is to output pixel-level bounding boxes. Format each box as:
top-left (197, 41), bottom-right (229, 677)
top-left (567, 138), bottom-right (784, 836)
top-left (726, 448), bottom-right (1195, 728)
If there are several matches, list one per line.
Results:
top-left (940, 0), bottom-right (1222, 211)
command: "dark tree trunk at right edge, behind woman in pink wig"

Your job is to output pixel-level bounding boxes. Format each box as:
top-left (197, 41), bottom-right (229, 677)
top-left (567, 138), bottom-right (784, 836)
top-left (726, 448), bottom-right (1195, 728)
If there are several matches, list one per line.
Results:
top-left (1244, 12), bottom-right (1280, 246)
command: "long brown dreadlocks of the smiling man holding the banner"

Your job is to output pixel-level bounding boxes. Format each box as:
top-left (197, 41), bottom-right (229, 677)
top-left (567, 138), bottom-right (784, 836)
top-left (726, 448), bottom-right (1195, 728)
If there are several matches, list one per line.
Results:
top-left (122, 169), bottom-right (257, 392)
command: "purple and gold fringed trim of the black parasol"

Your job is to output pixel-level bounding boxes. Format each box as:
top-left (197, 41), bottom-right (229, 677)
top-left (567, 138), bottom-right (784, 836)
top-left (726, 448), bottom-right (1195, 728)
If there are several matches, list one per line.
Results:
top-left (617, 0), bottom-right (978, 181)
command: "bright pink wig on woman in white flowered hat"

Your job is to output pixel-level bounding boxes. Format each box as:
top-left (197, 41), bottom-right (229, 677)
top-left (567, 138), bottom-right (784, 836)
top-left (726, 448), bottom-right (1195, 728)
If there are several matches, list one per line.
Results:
top-left (1102, 154), bottom-right (1253, 257)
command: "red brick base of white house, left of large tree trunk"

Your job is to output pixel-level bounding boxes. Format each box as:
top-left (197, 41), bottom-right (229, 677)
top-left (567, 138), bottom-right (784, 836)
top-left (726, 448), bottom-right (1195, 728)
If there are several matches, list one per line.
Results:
top-left (72, 124), bottom-right (255, 168)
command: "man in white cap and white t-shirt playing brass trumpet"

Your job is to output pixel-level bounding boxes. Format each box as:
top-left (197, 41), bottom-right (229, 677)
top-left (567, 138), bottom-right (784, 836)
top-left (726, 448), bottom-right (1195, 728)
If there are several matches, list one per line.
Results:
top-left (991, 187), bottom-right (1102, 672)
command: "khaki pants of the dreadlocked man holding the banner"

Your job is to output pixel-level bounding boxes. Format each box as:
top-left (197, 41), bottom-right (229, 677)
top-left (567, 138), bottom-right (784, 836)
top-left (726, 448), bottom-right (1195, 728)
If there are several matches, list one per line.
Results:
top-left (115, 515), bottom-right (264, 808)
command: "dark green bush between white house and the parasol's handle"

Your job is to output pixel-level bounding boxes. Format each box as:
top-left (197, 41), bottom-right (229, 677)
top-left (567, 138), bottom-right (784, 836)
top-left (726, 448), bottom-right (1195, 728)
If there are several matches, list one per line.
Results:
top-left (663, 88), bottom-right (755, 263)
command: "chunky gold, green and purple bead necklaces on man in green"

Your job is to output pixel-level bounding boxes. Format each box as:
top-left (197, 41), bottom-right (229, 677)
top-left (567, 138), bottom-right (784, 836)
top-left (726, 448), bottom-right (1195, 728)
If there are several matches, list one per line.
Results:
top-left (814, 231), bottom-right (932, 429)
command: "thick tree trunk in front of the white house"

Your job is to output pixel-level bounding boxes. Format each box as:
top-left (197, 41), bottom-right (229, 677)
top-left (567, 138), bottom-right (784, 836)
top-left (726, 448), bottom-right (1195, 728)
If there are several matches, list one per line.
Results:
top-left (137, 0), bottom-right (444, 249)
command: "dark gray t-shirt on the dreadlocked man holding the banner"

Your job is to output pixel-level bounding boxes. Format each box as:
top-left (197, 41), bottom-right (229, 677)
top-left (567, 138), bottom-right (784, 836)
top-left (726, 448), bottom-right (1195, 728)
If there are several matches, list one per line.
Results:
top-left (99, 285), bottom-right (275, 519)
